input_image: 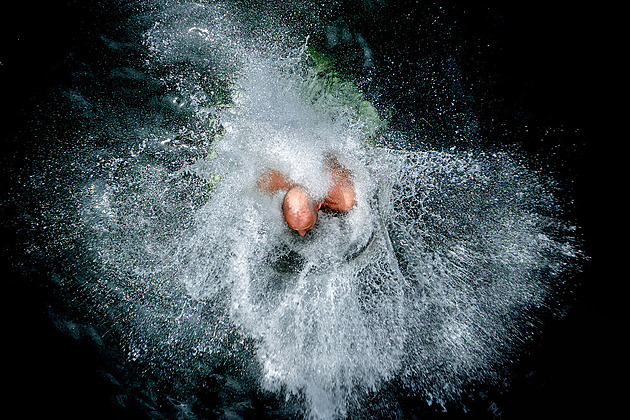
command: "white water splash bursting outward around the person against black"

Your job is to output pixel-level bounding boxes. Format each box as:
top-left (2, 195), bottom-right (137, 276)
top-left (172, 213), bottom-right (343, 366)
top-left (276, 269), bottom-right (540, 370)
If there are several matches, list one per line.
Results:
top-left (17, 2), bottom-right (579, 418)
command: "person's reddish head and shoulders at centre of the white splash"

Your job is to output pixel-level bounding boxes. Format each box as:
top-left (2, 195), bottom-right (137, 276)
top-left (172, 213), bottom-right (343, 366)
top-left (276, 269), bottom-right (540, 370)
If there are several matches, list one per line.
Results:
top-left (258, 156), bottom-right (356, 236)
